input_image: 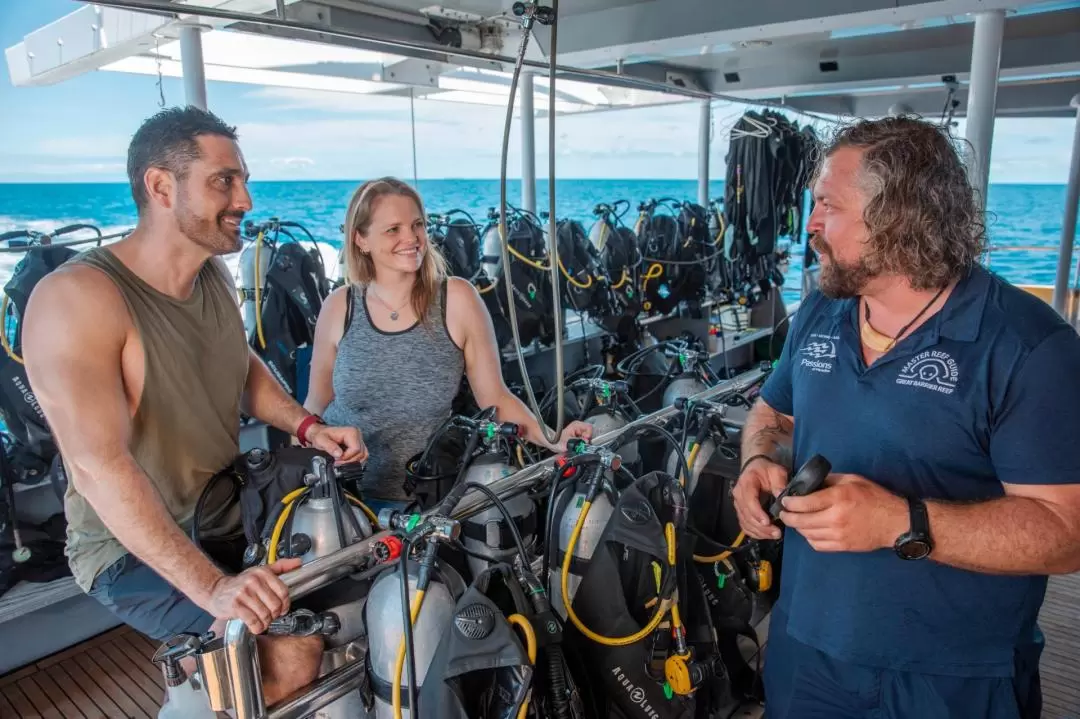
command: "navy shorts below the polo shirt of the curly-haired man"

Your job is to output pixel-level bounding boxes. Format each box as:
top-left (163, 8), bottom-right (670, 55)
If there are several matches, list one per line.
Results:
top-left (765, 611), bottom-right (1042, 719)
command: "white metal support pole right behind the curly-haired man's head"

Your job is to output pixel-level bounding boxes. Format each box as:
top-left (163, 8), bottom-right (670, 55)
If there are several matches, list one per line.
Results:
top-left (964, 10), bottom-right (1005, 208)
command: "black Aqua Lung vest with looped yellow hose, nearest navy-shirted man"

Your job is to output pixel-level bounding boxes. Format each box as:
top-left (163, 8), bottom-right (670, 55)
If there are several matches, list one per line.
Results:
top-left (565, 472), bottom-right (727, 719)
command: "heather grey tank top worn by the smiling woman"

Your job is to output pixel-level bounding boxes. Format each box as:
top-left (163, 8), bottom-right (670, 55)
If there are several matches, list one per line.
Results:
top-left (323, 280), bottom-right (464, 500)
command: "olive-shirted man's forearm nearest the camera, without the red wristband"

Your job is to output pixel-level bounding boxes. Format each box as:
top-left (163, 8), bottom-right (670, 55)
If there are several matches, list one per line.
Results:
top-left (76, 456), bottom-right (224, 608)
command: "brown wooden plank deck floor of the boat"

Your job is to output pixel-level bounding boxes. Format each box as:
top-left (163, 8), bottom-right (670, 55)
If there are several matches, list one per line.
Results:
top-left (0, 574), bottom-right (1080, 719)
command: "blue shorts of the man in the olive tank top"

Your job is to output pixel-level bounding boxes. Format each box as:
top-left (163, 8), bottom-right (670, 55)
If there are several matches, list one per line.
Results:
top-left (89, 538), bottom-right (243, 641)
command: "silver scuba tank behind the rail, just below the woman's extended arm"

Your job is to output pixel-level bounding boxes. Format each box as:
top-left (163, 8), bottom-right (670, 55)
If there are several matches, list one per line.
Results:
top-left (461, 451), bottom-right (537, 576)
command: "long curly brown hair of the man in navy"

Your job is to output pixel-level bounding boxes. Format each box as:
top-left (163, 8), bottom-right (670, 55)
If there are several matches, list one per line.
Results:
top-left (821, 117), bottom-right (986, 289)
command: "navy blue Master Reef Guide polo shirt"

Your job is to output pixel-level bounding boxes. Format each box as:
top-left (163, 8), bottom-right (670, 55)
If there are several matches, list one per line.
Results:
top-left (761, 260), bottom-right (1080, 677)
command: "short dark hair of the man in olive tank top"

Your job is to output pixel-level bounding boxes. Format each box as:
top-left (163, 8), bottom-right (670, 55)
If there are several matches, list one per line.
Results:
top-left (127, 105), bottom-right (237, 212)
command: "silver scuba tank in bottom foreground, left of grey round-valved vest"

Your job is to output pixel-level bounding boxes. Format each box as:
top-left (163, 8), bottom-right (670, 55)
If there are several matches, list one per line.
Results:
top-left (364, 564), bottom-right (464, 719)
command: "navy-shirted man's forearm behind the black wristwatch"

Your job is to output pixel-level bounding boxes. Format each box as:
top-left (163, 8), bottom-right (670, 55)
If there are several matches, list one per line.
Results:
top-left (927, 497), bottom-right (1080, 574)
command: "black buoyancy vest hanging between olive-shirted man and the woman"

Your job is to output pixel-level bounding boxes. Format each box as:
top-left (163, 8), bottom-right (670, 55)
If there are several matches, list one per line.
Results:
top-left (251, 242), bottom-right (330, 398)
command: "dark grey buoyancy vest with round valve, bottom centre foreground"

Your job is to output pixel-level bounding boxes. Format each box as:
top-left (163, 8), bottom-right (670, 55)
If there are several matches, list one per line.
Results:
top-left (418, 565), bottom-right (535, 719)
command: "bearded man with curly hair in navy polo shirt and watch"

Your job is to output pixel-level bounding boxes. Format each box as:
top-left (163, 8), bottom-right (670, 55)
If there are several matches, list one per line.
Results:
top-left (734, 118), bottom-right (1080, 719)
